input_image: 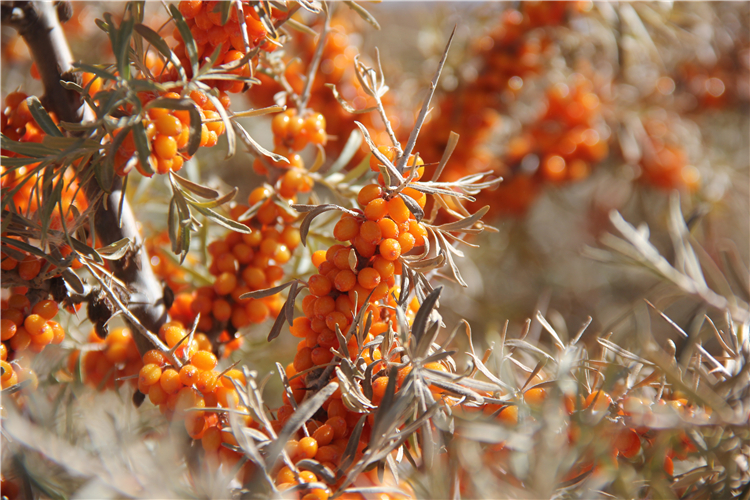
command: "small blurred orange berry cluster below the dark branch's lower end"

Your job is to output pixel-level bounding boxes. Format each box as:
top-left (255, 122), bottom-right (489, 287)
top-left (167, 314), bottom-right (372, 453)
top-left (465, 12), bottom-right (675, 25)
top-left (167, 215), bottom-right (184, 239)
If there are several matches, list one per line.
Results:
top-left (67, 328), bottom-right (143, 390)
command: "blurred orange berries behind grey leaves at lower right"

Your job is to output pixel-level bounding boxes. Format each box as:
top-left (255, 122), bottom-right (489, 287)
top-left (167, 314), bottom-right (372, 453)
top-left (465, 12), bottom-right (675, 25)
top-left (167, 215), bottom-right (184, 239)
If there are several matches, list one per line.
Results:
top-left (453, 377), bottom-right (710, 495)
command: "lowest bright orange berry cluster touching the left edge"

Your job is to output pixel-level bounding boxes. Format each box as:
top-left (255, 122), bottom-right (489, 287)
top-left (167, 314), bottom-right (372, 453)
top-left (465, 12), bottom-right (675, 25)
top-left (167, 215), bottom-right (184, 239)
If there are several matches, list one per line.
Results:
top-left (0, 294), bottom-right (65, 390)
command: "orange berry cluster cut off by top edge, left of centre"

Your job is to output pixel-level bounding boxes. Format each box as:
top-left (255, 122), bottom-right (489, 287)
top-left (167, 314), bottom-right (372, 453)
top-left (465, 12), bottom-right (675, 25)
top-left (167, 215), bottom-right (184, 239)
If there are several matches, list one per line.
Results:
top-left (175, 0), bottom-right (272, 89)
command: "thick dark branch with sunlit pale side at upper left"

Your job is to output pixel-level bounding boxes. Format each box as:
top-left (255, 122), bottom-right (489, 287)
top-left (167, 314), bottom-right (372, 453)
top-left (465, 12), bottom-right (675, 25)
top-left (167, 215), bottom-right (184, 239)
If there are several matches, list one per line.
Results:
top-left (0, 2), bottom-right (168, 352)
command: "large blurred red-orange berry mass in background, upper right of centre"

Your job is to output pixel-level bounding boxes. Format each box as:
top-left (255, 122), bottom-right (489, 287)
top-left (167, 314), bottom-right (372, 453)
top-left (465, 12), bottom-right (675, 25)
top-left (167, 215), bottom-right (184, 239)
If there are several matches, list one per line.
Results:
top-left (422, 2), bottom-right (608, 215)
